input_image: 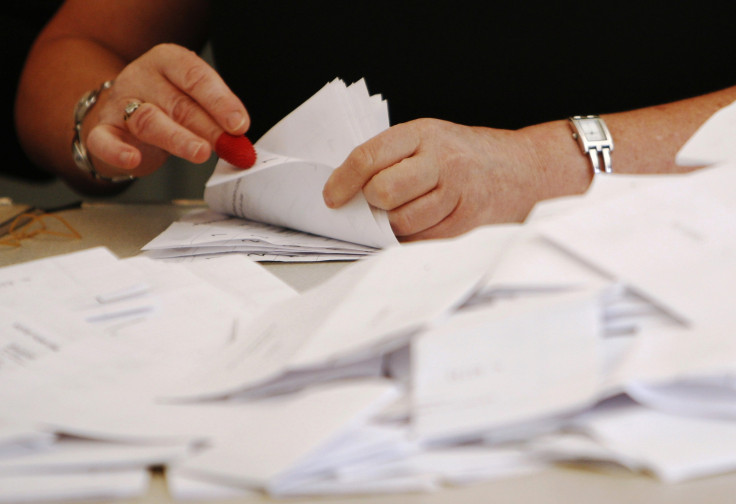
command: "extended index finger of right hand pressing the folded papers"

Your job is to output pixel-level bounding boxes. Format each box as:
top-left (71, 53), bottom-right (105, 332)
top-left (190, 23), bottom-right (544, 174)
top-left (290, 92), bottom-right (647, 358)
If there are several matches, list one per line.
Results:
top-left (322, 123), bottom-right (420, 208)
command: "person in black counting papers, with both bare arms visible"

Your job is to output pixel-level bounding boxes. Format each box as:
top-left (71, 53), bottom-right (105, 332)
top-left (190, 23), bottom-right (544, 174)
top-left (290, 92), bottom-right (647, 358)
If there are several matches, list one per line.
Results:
top-left (16, 0), bottom-right (736, 241)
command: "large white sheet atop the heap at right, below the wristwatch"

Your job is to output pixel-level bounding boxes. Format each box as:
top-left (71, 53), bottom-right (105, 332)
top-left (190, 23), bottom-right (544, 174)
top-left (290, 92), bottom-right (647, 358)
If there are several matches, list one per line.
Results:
top-left (537, 164), bottom-right (736, 327)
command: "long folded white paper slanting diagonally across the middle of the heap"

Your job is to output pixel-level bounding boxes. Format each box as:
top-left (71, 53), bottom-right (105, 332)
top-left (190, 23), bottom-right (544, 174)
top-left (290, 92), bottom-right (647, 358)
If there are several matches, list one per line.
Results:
top-left (164, 227), bottom-right (513, 399)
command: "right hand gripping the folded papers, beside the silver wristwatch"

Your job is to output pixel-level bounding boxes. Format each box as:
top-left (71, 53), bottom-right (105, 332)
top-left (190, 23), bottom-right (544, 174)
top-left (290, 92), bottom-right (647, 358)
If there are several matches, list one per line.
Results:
top-left (323, 119), bottom-right (546, 241)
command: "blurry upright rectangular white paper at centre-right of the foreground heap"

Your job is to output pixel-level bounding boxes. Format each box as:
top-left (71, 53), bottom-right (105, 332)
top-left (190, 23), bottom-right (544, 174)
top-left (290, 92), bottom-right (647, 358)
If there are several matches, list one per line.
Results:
top-left (411, 291), bottom-right (601, 443)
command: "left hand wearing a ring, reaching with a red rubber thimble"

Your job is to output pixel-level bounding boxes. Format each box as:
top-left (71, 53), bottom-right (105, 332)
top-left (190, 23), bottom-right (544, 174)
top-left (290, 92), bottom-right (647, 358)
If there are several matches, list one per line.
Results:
top-left (85, 44), bottom-right (250, 176)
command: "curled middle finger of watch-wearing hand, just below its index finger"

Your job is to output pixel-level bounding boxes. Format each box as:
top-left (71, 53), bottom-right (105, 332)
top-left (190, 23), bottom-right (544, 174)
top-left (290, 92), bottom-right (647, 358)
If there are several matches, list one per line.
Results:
top-left (363, 156), bottom-right (439, 210)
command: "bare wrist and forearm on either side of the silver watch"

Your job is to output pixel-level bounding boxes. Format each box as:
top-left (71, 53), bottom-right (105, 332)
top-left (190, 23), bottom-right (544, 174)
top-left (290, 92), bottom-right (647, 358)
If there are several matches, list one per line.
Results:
top-left (521, 86), bottom-right (736, 198)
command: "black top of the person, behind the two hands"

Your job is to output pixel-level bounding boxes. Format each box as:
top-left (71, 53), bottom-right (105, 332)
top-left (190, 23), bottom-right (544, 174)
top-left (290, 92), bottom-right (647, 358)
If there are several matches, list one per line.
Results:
top-left (212, 0), bottom-right (736, 139)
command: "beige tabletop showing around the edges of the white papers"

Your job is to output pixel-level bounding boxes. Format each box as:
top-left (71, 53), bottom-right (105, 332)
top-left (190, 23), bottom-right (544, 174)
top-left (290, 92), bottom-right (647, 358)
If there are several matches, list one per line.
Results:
top-left (0, 202), bottom-right (736, 504)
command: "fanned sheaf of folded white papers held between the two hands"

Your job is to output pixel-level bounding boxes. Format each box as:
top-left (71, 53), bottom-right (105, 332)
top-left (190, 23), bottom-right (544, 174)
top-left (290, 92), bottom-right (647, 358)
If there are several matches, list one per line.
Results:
top-left (205, 80), bottom-right (397, 248)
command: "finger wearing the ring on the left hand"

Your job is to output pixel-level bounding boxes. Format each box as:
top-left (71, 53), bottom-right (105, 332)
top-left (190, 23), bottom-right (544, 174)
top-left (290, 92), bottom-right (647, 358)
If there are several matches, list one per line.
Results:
top-left (125, 103), bottom-right (212, 163)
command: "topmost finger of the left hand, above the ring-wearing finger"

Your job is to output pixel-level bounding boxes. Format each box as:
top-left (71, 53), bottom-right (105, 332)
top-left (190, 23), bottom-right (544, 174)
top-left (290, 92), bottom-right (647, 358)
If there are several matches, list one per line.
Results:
top-left (156, 44), bottom-right (250, 135)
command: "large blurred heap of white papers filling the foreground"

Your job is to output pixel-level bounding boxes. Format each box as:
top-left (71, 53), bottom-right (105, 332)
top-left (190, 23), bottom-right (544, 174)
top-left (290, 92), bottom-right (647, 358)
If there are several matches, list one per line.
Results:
top-left (0, 97), bottom-right (736, 501)
